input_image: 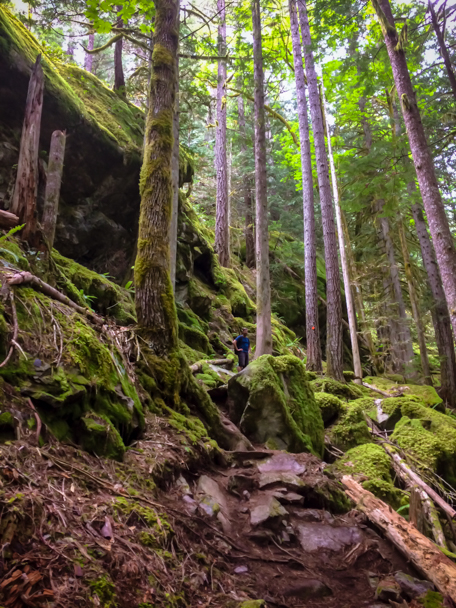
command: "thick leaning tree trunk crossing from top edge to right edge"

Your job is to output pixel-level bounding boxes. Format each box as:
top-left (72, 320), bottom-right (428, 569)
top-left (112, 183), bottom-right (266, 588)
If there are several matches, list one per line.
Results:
top-left (372, 0), bottom-right (456, 342)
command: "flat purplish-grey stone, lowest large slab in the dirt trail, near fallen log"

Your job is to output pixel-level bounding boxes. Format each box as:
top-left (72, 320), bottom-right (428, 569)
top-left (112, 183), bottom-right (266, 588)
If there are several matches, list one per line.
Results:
top-left (297, 523), bottom-right (363, 553)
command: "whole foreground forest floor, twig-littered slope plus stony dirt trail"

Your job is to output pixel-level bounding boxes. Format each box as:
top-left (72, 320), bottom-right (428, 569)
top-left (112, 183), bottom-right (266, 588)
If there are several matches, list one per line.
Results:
top-left (0, 408), bottom-right (429, 608)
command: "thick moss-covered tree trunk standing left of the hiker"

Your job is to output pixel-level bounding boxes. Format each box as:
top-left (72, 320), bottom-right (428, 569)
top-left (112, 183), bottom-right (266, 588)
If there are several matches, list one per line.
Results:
top-left (135, 0), bottom-right (179, 355)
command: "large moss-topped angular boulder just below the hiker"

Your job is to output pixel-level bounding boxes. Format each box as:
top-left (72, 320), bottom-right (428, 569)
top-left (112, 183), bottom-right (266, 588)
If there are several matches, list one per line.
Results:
top-left (228, 355), bottom-right (324, 456)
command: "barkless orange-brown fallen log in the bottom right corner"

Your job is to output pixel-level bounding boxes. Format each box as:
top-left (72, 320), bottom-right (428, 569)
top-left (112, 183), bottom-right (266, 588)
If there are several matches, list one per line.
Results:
top-left (342, 475), bottom-right (456, 601)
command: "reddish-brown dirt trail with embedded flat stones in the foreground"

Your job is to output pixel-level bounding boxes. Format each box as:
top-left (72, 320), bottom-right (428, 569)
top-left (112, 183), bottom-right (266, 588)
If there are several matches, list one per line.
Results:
top-left (167, 450), bottom-right (424, 608)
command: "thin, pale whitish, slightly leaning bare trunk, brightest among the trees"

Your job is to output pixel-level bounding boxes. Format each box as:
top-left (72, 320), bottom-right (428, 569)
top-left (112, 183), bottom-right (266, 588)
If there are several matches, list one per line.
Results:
top-left (321, 79), bottom-right (363, 384)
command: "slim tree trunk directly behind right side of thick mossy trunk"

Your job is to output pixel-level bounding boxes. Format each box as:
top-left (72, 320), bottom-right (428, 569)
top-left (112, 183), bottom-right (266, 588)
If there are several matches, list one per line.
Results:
top-left (169, 8), bottom-right (180, 290)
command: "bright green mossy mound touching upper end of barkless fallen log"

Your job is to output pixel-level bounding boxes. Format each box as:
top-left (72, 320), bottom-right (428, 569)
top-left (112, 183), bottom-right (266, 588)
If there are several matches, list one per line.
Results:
top-left (333, 443), bottom-right (406, 508)
